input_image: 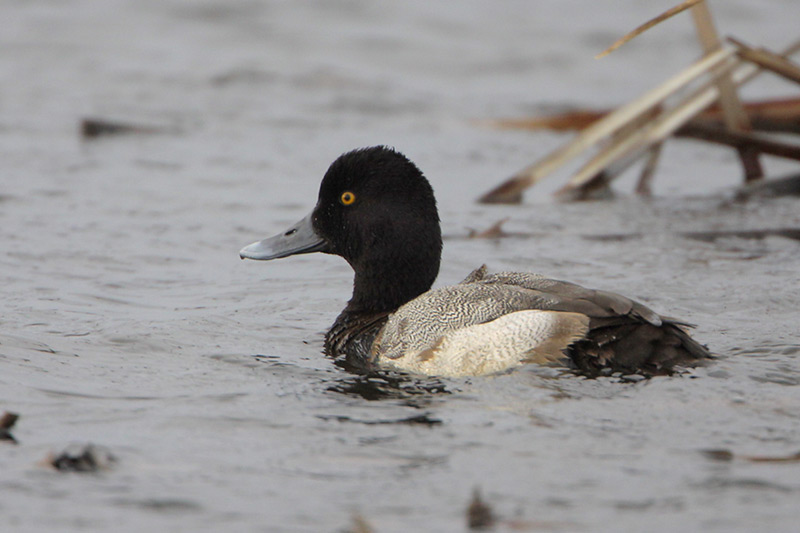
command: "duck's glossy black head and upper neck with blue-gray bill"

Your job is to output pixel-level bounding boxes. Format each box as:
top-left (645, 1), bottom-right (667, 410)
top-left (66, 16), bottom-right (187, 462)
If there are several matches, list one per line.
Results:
top-left (240, 146), bottom-right (442, 313)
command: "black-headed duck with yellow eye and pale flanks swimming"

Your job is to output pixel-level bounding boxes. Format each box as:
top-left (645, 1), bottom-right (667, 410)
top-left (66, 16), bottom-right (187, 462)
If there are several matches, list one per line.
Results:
top-left (239, 146), bottom-right (712, 377)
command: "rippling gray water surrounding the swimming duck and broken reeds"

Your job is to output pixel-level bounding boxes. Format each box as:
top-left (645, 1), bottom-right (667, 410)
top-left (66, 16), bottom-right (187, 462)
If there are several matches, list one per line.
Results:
top-left (0, 0), bottom-right (800, 533)
